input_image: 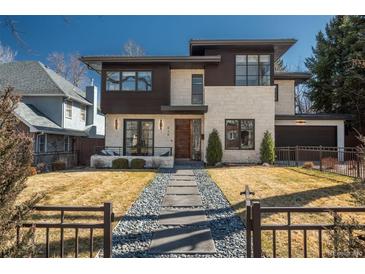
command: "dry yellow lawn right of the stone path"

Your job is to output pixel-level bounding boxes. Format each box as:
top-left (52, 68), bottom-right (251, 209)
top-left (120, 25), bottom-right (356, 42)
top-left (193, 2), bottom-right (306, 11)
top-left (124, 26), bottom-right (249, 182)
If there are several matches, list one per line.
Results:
top-left (208, 166), bottom-right (365, 257)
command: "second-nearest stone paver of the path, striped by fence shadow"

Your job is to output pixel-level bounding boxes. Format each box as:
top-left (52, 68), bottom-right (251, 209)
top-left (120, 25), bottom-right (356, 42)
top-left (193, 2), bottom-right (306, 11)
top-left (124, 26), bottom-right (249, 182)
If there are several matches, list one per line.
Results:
top-left (158, 209), bottom-right (207, 225)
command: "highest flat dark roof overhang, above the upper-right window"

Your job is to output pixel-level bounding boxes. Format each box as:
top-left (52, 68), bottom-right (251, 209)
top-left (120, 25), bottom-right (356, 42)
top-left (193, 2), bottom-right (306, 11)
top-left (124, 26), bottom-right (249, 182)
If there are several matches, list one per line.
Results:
top-left (190, 39), bottom-right (297, 60)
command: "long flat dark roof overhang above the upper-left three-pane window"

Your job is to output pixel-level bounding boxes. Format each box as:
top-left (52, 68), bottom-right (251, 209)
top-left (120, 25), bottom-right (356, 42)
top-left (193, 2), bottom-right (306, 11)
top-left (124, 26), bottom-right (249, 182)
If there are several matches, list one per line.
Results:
top-left (80, 55), bottom-right (221, 72)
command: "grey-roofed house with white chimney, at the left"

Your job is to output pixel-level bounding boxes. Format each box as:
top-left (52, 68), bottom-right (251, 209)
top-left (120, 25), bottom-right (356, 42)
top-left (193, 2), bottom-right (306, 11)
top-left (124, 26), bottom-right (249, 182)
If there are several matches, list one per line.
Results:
top-left (0, 61), bottom-right (105, 166)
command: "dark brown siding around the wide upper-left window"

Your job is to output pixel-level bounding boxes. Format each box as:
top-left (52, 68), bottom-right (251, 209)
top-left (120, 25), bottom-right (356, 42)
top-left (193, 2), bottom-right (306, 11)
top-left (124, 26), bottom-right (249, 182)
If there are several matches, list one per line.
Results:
top-left (101, 63), bottom-right (170, 114)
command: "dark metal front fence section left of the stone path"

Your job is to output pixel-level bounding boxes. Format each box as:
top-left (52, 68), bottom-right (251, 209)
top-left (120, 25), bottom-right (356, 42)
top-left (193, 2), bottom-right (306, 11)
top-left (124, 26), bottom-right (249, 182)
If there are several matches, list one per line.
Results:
top-left (16, 202), bottom-right (114, 258)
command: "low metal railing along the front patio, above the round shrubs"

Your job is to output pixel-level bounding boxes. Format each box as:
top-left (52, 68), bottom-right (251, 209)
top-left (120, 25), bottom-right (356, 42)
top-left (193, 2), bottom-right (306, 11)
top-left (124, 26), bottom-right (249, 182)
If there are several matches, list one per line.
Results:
top-left (95, 146), bottom-right (172, 157)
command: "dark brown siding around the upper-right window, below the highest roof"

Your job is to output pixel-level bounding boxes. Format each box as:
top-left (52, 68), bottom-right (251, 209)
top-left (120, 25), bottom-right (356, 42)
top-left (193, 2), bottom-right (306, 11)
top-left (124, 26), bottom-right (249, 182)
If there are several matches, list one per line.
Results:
top-left (204, 48), bottom-right (274, 86)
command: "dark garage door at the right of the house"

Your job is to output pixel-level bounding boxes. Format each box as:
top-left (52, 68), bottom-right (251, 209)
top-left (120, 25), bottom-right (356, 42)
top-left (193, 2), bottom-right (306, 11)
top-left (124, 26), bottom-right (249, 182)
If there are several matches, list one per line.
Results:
top-left (275, 126), bottom-right (337, 147)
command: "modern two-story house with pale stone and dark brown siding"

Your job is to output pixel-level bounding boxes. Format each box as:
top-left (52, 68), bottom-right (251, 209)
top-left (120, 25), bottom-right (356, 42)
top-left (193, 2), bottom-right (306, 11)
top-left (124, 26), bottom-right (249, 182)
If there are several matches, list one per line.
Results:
top-left (81, 39), bottom-right (346, 167)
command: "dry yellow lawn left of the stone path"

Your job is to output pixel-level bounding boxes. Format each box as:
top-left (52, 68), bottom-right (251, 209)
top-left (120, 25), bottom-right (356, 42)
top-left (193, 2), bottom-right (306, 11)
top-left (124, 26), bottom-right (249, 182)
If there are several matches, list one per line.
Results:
top-left (19, 170), bottom-right (155, 257)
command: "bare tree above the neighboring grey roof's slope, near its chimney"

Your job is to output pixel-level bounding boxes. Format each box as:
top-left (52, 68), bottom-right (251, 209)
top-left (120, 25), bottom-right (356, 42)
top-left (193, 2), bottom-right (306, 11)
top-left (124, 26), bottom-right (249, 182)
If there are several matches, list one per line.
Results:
top-left (47, 52), bottom-right (88, 88)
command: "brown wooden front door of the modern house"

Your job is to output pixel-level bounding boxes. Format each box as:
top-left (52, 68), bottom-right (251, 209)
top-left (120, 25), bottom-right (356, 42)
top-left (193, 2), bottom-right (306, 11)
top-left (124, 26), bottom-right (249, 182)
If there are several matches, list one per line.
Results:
top-left (175, 119), bottom-right (191, 159)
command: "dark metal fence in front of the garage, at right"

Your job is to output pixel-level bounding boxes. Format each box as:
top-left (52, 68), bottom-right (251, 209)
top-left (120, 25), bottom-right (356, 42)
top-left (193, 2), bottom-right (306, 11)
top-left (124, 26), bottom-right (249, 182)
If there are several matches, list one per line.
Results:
top-left (275, 146), bottom-right (365, 179)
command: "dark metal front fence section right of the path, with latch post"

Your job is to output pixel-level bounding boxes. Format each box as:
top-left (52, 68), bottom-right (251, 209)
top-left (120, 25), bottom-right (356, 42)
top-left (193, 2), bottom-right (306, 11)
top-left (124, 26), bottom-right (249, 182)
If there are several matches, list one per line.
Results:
top-left (241, 185), bottom-right (365, 258)
